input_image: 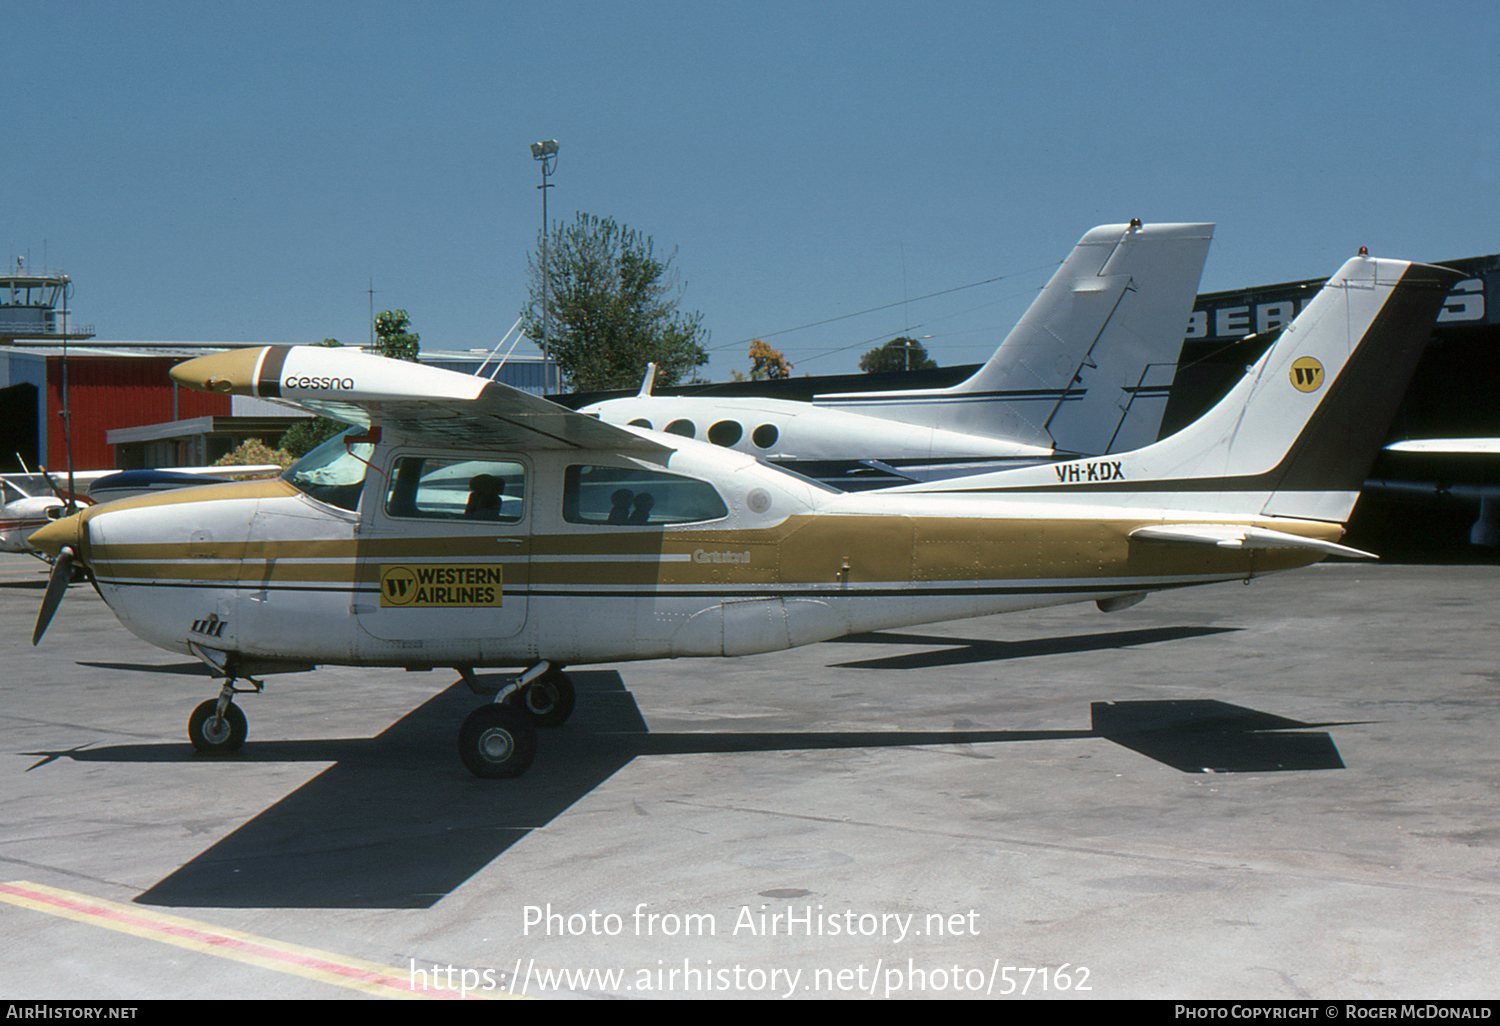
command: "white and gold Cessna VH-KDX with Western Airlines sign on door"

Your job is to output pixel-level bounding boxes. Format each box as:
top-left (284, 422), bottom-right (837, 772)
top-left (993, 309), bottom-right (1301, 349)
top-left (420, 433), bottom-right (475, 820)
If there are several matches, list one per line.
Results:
top-left (32, 257), bottom-right (1458, 777)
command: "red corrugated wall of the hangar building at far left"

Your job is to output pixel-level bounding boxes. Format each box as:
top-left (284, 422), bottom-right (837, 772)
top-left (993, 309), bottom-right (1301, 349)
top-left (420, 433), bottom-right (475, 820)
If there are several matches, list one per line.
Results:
top-left (47, 354), bottom-right (230, 470)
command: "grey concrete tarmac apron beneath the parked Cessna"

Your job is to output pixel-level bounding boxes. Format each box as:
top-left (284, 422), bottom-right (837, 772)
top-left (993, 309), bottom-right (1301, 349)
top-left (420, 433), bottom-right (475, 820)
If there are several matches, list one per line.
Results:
top-left (0, 557), bottom-right (1500, 1001)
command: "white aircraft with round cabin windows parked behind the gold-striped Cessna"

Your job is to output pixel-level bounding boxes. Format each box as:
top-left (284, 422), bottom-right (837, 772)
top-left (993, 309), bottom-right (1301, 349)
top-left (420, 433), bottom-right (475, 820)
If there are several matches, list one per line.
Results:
top-left (584, 221), bottom-right (1214, 479)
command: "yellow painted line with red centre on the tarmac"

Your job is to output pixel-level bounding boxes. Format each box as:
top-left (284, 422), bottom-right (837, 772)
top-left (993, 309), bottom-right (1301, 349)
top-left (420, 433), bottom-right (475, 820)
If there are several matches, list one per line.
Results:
top-left (0, 881), bottom-right (515, 1001)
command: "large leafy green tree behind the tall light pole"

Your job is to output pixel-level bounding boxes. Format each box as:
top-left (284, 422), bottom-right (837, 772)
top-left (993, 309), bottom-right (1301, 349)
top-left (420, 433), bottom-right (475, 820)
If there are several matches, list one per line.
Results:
top-left (522, 213), bottom-right (708, 392)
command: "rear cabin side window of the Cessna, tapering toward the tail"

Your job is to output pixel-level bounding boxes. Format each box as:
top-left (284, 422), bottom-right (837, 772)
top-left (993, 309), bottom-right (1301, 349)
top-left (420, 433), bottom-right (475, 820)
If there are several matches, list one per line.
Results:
top-left (563, 467), bottom-right (729, 527)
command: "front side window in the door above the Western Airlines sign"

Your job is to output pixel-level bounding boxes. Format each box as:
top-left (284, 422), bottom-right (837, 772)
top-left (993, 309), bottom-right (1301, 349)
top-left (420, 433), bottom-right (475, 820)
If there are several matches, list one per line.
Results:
top-left (386, 456), bottom-right (527, 524)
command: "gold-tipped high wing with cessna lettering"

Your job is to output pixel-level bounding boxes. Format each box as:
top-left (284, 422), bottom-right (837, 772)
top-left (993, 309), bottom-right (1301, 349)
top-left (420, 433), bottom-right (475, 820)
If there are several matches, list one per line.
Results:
top-left (171, 345), bottom-right (672, 458)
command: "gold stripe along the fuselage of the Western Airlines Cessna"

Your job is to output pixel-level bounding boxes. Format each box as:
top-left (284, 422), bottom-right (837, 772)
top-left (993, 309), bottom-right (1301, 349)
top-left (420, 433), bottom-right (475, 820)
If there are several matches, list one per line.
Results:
top-left (79, 515), bottom-right (1338, 590)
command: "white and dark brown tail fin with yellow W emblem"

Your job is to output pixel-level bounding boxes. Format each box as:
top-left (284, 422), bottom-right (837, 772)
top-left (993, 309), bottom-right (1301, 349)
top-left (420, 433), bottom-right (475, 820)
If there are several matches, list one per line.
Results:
top-left (921, 257), bottom-right (1463, 522)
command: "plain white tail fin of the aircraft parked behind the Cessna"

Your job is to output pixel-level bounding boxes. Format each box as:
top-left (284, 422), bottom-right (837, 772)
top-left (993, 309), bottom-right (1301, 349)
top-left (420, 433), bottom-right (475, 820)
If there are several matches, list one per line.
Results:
top-left (815, 221), bottom-right (1214, 453)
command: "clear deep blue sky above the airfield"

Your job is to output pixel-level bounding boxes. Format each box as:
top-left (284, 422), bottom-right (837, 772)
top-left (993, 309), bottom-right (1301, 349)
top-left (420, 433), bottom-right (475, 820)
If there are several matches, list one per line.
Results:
top-left (0, 0), bottom-right (1500, 380)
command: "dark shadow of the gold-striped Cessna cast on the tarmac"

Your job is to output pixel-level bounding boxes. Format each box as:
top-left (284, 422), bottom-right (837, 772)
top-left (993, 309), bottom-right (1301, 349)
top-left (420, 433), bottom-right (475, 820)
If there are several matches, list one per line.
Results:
top-left (27, 632), bottom-right (1344, 909)
